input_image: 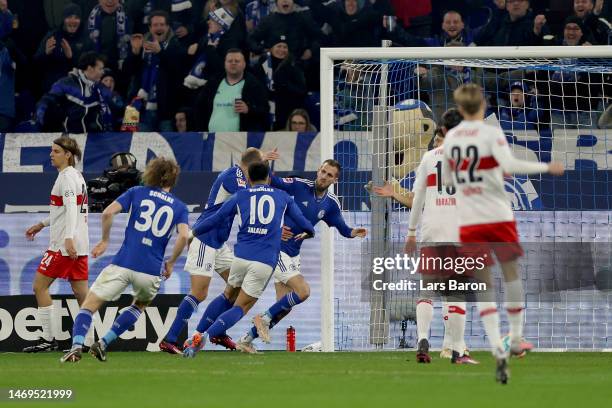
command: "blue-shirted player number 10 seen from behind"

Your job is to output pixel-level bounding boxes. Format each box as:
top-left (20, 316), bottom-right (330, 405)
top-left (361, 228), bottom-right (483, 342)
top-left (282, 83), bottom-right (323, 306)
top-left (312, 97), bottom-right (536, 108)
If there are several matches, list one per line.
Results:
top-left (183, 162), bottom-right (314, 357)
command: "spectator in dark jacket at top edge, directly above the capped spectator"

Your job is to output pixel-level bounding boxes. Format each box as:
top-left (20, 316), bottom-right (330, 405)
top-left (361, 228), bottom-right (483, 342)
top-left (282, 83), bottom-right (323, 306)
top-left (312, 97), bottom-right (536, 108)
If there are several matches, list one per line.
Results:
top-left (248, 0), bottom-right (319, 61)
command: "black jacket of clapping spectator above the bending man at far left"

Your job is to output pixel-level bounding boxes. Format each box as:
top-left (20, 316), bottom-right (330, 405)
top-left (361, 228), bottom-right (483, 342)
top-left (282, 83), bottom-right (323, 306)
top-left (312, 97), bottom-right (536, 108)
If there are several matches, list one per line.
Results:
top-left (34, 26), bottom-right (94, 92)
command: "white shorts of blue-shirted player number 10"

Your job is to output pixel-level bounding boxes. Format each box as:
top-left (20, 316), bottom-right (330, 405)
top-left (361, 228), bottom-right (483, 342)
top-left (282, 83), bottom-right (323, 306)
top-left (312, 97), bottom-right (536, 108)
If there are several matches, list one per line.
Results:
top-left (227, 258), bottom-right (272, 299)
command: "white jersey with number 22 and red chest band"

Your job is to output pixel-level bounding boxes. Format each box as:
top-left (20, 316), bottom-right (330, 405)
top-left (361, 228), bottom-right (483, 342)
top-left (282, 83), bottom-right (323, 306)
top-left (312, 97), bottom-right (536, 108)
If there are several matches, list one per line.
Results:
top-left (442, 120), bottom-right (548, 226)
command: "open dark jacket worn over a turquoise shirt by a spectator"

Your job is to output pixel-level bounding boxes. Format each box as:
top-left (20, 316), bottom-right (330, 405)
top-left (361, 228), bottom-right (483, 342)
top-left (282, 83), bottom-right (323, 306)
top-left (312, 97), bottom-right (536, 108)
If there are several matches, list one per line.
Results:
top-left (194, 72), bottom-right (269, 132)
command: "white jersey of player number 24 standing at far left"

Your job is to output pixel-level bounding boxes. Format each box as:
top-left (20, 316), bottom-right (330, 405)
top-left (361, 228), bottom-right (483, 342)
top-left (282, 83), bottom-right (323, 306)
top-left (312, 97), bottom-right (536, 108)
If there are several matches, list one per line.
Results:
top-left (49, 166), bottom-right (89, 256)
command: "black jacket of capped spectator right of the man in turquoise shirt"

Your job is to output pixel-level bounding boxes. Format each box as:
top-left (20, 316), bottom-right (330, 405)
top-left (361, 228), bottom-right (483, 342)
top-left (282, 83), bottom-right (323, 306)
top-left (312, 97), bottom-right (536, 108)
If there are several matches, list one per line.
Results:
top-left (254, 55), bottom-right (307, 130)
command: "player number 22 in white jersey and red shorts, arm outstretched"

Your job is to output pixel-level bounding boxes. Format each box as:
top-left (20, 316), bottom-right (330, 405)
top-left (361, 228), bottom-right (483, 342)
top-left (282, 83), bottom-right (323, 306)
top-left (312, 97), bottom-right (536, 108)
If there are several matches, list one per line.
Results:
top-left (442, 84), bottom-right (563, 384)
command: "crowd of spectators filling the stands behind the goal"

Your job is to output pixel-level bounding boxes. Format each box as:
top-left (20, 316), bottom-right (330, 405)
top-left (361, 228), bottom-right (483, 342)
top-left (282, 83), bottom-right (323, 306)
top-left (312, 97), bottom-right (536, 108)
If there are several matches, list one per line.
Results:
top-left (0, 0), bottom-right (612, 133)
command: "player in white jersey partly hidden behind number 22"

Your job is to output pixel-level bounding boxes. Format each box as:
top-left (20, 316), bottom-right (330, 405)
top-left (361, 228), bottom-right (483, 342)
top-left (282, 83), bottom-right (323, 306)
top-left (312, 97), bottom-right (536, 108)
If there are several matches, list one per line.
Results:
top-left (406, 109), bottom-right (478, 364)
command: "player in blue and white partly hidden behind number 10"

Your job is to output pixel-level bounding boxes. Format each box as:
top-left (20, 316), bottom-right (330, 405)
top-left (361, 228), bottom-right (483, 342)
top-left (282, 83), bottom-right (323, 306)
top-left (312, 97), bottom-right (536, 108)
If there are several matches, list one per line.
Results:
top-left (159, 147), bottom-right (276, 354)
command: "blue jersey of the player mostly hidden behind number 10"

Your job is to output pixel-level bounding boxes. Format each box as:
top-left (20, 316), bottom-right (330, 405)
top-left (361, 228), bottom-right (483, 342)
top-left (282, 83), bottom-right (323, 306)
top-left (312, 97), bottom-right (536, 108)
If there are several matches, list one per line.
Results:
top-left (194, 165), bottom-right (247, 249)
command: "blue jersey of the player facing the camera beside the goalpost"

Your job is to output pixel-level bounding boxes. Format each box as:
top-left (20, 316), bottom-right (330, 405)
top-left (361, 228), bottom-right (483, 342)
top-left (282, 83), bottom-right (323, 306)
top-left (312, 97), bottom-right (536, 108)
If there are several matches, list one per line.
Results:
top-left (270, 176), bottom-right (353, 256)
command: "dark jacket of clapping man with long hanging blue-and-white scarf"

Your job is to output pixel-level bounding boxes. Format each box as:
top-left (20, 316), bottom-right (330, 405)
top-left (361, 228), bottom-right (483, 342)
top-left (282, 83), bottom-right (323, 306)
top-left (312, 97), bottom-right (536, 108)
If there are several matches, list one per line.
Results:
top-left (123, 31), bottom-right (187, 120)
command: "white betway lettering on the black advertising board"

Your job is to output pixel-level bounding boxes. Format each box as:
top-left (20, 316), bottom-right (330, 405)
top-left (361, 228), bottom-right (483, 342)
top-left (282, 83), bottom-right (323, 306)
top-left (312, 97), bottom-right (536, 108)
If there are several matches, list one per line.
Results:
top-left (0, 299), bottom-right (177, 351)
